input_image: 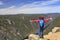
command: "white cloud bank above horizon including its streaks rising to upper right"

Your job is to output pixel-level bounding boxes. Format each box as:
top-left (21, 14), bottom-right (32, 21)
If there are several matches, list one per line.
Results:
top-left (0, 0), bottom-right (60, 15)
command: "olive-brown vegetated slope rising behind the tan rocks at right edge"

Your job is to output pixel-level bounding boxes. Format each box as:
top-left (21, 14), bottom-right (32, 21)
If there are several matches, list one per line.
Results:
top-left (44, 16), bottom-right (60, 34)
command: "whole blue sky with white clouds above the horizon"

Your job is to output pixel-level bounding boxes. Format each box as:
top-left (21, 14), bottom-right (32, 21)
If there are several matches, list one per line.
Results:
top-left (0, 0), bottom-right (60, 15)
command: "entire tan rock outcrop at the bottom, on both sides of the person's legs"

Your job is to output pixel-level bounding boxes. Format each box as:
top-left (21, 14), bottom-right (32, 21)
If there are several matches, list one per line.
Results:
top-left (24, 27), bottom-right (60, 40)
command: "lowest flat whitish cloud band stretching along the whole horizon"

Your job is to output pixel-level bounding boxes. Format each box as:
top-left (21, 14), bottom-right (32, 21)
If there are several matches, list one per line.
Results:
top-left (0, 6), bottom-right (60, 15)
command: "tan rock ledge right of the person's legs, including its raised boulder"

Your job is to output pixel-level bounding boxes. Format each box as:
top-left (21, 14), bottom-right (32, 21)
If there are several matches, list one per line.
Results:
top-left (44, 27), bottom-right (60, 40)
